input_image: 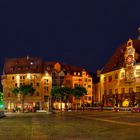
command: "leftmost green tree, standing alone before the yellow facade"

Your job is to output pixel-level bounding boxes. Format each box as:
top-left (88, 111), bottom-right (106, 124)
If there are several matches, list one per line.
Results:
top-left (12, 85), bottom-right (35, 112)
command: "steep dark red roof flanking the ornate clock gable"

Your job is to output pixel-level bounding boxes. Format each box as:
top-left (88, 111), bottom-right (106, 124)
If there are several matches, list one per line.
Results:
top-left (102, 40), bottom-right (140, 73)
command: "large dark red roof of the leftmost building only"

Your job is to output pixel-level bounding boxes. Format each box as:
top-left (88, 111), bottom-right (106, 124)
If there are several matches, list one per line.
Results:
top-left (3, 57), bottom-right (43, 74)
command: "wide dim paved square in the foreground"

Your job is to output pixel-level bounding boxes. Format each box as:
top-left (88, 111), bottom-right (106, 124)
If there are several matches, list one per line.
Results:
top-left (0, 111), bottom-right (140, 140)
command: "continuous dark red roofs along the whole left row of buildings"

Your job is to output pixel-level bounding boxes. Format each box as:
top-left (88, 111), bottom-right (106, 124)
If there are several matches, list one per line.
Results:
top-left (4, 57), bottom-right (89, 75)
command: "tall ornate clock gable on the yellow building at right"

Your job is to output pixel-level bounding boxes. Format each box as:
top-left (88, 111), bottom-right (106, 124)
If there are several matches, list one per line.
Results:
top-left (124, 39), bottom-right (135, 82)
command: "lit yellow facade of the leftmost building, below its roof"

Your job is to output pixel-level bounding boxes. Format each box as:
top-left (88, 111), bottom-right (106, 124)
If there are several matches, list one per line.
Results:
top-left (2, 73), bottom-right (52, 110)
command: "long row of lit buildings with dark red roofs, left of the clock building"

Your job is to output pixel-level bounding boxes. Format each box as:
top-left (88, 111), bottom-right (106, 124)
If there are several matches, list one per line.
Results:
top-left (1, 56), bottom-right (92, 110)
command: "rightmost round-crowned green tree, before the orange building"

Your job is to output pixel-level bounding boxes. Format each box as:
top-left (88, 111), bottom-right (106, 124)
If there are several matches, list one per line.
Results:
top-left (72, 86), bottom-right (87, 109)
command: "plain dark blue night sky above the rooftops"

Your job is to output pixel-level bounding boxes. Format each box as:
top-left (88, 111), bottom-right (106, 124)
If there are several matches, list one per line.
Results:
top-left (0, 0), bottom-right (140, 73)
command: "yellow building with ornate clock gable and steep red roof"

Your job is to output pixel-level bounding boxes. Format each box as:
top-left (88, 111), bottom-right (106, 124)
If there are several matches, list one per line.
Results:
top-left (99, 39), bottom-right (140, 106)
